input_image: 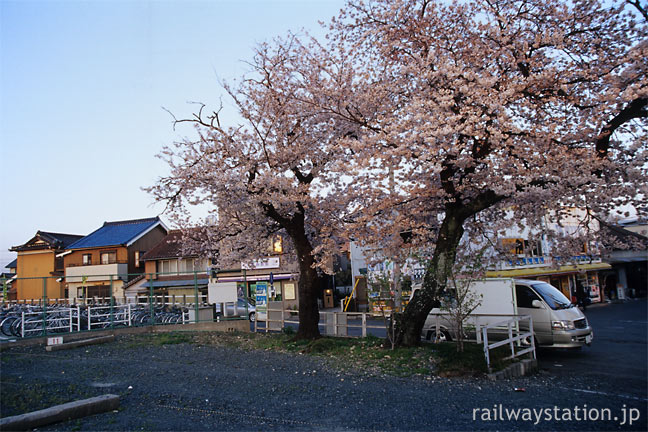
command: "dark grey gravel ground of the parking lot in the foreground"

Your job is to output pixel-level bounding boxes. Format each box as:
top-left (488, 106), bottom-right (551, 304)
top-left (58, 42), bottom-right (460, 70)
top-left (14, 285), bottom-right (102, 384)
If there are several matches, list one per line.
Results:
top-left (1, 302), bottom-right (648, 431)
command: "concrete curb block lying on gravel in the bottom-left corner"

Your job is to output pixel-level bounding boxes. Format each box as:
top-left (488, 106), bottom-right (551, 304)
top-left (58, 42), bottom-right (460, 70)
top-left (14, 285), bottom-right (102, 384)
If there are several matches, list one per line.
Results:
top-left (0, 394), bottom-right (119, 431)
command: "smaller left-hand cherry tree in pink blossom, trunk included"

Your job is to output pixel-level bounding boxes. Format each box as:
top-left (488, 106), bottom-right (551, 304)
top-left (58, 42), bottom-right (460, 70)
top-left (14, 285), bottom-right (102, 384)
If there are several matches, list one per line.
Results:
top-left (148, 35), bottom-right (359, 338)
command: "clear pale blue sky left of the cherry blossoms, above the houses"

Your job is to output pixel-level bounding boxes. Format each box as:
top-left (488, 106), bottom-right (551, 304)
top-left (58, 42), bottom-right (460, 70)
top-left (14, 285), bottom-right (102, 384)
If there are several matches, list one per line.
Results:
top-left (0, 0), bottom-right (344, 271)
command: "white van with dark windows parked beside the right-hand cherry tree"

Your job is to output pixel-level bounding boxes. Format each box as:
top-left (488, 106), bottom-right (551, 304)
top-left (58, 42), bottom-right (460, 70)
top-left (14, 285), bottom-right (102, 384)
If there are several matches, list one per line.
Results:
top-left (421, 279), bottom-right (594, 348)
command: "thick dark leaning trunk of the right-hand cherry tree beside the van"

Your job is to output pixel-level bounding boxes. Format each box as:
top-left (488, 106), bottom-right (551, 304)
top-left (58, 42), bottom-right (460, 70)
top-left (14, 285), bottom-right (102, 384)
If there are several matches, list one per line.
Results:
top-left (396, 208), bottom-right (466, 346)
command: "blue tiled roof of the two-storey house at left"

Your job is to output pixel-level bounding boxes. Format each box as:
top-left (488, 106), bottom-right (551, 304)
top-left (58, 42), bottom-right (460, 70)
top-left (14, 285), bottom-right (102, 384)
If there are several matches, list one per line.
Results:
top-left (67, 217), bottom-right (160, 249)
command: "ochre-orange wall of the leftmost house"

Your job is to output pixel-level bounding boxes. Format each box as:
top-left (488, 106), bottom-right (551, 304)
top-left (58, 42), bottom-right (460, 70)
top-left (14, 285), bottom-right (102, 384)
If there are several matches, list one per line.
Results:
top-left (15, 250), bottom-right (64, 300)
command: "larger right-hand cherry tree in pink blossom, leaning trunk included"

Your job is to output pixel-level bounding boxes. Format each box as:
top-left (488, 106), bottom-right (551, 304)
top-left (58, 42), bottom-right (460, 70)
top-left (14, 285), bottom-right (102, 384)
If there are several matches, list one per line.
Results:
top-left (330, 0), bottom-right (648, 345)
